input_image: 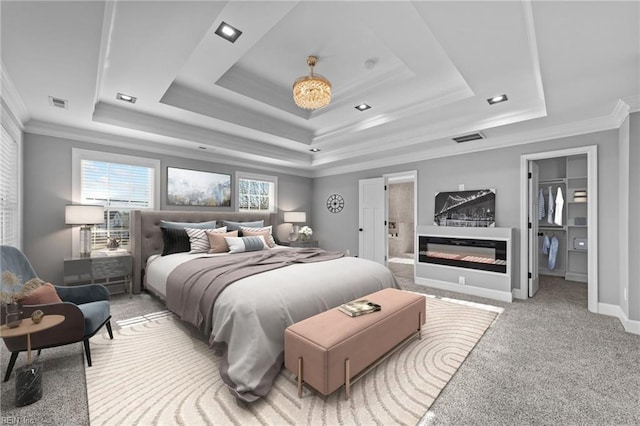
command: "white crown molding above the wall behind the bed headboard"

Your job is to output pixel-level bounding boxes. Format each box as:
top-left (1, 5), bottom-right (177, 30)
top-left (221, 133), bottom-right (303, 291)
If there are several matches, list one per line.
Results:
top-left (24, 120), bottom-right (312, 177)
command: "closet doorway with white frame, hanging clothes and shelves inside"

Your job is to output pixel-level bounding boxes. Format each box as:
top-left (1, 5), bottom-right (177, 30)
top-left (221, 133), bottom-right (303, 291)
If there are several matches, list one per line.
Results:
top-left (514, 146), bottom-right (598, 312)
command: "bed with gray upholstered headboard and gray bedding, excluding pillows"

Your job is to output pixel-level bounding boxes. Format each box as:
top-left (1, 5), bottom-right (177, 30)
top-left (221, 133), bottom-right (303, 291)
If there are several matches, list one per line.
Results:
top-left (131, 211), bottom-right (398, 402)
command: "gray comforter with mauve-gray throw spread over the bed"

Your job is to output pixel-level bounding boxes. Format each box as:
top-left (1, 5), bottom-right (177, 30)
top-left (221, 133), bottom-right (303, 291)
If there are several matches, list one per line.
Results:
top-left (167, 249), bottom-right (397, 402)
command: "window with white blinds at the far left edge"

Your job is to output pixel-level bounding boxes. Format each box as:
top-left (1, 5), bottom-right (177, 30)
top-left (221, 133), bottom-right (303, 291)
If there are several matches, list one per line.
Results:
top-left (0, 127), bottom-right (19, 246)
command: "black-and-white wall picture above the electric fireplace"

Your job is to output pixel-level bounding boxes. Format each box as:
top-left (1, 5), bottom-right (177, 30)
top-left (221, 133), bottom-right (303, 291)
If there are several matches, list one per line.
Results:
top-left (433, 189), bottom-right (496, 228)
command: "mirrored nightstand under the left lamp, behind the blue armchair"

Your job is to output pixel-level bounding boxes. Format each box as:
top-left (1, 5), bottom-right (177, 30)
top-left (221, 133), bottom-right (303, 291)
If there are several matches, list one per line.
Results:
top-left (64, 253), bottom-right (133, 297)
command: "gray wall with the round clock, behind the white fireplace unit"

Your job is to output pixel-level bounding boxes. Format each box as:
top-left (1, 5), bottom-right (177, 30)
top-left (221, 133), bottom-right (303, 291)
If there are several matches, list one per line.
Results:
top-left (313, 130), bottom-right (624, 305)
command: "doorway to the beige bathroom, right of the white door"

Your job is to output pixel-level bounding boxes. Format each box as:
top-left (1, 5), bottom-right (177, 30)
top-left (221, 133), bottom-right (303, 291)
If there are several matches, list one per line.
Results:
top-left (384, 170), bottom-right (417, 279)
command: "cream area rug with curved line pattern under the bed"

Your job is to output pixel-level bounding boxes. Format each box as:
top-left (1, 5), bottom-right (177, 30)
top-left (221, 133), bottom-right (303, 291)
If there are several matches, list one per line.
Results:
top-left (86, 297), bottom-right (500, 426)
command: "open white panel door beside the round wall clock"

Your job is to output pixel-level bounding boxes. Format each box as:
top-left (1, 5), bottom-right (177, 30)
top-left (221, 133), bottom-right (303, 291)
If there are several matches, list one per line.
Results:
top-left (358, 177), bottom-right (387, 265)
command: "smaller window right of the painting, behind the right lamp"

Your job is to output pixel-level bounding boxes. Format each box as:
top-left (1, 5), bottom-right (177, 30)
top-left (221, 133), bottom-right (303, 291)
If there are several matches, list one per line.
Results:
top-left (236, 172), bottom-right (278, 213)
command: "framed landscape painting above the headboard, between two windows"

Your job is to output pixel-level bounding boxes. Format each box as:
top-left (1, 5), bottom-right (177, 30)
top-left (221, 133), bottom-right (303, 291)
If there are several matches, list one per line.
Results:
top-left (167, 167), bottom-right (231, 207)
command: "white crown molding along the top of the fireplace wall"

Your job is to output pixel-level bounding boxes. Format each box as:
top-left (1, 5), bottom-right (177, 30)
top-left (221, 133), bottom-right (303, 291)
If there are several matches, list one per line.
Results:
top-left (313, 106), bottom-right (628, 178)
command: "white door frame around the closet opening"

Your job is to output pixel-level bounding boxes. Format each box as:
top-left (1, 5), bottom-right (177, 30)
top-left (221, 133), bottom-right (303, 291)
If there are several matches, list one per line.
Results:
top-left (513, 145), bottom-right (598, 313)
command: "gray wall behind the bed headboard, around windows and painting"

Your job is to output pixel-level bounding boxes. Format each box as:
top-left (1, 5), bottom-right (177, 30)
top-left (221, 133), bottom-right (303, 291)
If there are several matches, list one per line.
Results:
top-left (22, 133), bottom-right (313, 284)
